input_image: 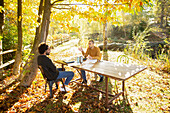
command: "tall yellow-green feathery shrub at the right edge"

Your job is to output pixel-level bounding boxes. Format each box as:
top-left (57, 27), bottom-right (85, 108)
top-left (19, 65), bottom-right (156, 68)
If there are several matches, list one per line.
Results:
top-left (124, 27), bottom-right (170, 73)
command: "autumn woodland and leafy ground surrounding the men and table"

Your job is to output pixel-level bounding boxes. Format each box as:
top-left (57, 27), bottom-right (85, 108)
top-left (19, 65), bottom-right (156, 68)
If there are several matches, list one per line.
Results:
top-left (0, 0), bottom-right (170, 112)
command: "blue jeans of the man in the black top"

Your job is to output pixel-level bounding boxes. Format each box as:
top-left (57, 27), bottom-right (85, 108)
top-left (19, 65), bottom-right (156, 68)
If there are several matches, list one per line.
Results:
top-left (57, 68), bottom-right (74, 85)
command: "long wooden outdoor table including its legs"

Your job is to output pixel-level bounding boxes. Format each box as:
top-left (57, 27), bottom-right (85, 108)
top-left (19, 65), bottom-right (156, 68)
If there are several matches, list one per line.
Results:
top-left (55, 60), bottom-right (147, 108)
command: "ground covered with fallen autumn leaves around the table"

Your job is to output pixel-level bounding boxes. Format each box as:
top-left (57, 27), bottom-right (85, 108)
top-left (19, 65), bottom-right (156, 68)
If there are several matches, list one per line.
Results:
top-left (0, 40), bottom-right (170, 113)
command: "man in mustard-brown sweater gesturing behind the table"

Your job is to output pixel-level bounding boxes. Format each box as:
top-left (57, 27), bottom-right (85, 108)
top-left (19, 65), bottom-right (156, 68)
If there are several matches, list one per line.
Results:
top-left (78, 40), bottom-right (103, 83)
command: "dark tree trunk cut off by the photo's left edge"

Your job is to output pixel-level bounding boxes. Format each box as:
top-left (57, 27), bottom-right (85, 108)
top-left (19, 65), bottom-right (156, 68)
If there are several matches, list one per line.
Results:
top-left (0, 0), bottom-right (4, 79)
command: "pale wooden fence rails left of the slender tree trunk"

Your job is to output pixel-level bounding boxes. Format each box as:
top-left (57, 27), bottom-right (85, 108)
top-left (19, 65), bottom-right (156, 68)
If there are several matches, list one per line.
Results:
top-left (0, 49), bottom-right (16, 69)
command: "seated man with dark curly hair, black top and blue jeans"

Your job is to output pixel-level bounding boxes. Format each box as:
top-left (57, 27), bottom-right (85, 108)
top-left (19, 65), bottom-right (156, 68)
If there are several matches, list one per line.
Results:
top-left (37, 42), bottom-right (74, 88)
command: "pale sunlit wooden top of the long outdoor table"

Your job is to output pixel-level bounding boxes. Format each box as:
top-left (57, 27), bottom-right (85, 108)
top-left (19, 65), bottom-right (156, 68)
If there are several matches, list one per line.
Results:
top-left (68, 60), bottom-right (147, 80)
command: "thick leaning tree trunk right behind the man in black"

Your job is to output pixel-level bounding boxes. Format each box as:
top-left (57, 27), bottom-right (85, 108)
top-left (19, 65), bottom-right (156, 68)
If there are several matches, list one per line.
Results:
top-left (21, 0), bottom-right (51, 86)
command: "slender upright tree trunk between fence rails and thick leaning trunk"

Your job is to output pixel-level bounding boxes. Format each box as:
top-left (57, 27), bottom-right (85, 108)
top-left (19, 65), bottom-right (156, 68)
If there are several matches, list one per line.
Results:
top-left (13, 0), bottom-right (22, 75)
